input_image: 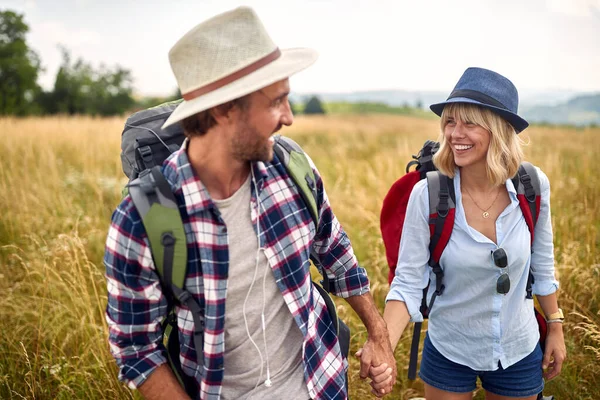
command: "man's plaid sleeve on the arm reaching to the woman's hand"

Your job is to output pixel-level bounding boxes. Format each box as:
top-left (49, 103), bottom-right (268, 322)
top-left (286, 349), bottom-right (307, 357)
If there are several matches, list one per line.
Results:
top-left (309, 158), bottom-right (370, 298)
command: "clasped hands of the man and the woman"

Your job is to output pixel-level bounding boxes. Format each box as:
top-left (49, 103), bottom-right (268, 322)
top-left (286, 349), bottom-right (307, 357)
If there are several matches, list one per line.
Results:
top-left (356, 335), bottom-right (397, 397)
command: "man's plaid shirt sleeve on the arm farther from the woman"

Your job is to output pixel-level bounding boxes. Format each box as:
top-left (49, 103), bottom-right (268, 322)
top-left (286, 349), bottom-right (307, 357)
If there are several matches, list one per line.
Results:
top-left (104, 199), bottom-right (167, 389)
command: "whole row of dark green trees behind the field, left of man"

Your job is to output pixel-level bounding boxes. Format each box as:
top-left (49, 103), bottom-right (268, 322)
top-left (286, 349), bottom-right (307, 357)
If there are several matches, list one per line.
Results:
top-left (0, 11), bottom-right (146, 116)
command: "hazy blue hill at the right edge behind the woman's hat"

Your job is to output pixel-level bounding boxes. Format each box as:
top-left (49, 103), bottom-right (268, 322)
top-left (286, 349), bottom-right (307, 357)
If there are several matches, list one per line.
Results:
top-left (521, 93), bottom-right (600, 126)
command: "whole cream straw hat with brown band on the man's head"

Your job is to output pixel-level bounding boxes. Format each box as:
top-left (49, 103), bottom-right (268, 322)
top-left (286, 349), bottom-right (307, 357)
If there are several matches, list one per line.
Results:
top-left (162, 7), bottom-right (317, 129)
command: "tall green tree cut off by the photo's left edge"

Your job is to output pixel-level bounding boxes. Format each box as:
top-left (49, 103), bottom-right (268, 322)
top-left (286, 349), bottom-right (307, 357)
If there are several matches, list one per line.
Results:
top-left (0, 11), bottom-right (41, 115)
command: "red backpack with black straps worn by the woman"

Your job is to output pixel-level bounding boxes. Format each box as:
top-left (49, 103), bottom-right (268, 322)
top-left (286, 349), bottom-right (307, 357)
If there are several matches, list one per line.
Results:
top-left (380, 140), bottom-right (547, 379)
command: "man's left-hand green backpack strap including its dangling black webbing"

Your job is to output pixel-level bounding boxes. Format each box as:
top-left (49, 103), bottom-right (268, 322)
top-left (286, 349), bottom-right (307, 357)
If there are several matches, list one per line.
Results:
top-left (127, 166), bottom-right (204, 398)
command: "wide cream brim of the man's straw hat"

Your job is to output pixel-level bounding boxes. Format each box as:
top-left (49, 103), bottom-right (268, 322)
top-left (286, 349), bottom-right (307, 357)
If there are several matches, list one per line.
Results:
top-left (162, 48), bottom-right (318, 129)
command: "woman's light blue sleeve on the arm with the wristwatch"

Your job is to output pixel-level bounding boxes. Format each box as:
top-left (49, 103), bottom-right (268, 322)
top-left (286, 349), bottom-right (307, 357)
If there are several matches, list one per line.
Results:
top-left (531, 167), bottom-right (558, 296)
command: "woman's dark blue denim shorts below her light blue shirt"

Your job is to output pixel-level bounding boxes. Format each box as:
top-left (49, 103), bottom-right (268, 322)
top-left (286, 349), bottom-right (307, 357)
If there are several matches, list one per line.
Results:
top-left (419, 335), bottom-right (544, 397)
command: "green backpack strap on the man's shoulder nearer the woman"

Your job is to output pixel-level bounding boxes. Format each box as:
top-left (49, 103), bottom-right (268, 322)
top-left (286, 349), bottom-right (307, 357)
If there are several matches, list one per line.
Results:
top-left (273, 136), bottom-right (319, 229)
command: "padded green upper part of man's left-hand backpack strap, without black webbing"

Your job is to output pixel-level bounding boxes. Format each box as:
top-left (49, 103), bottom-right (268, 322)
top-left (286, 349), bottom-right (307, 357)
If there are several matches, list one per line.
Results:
top-left (128, 166), bottom-right (187, 294)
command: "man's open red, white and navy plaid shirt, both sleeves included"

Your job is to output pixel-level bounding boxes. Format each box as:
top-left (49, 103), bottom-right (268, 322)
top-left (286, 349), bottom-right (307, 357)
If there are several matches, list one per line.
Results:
top-left (104, 143), bottom-right (369, 399)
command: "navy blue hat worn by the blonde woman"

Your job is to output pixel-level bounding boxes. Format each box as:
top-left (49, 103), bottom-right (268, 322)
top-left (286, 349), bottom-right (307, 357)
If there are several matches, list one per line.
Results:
top-left (429, 67), bottom-right (529, 133)
